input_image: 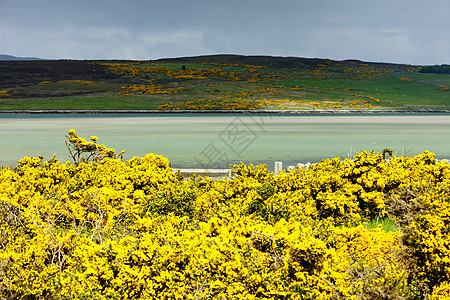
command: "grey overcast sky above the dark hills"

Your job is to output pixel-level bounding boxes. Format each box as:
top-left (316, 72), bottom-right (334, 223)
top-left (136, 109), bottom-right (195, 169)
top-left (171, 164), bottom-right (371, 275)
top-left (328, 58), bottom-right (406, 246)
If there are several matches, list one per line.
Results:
top-left (0, 0), bottom-right (450, 65)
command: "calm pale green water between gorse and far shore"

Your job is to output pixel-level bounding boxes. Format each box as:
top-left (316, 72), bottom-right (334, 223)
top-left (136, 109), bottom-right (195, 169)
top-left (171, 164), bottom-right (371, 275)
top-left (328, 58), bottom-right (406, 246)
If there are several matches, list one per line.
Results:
top-left (0, 114), bottom-right (450, 168)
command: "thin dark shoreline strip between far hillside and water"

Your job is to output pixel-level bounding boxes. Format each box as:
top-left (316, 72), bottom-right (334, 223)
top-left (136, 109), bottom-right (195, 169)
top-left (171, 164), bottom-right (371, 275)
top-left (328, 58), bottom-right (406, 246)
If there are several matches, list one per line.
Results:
top-left (0, 109), bottom-right (450, 115)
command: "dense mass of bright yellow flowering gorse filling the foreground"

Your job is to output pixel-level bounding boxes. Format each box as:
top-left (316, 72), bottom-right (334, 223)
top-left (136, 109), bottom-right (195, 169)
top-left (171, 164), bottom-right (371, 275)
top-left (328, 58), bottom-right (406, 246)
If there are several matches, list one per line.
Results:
top-left (0, 130), bottom-right (450, 299)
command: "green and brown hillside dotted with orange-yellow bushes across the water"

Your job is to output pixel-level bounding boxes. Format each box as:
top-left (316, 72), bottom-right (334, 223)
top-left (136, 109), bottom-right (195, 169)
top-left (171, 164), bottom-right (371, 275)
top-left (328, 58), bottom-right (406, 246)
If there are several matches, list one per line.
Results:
top-left (0, 55), bottom-right (450, 111)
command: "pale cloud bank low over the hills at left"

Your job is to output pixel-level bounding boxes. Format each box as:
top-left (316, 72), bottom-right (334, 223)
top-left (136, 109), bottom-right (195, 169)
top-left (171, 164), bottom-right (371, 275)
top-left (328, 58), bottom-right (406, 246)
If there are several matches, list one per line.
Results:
top-left (0, 26), bottom-right (207, 59)
